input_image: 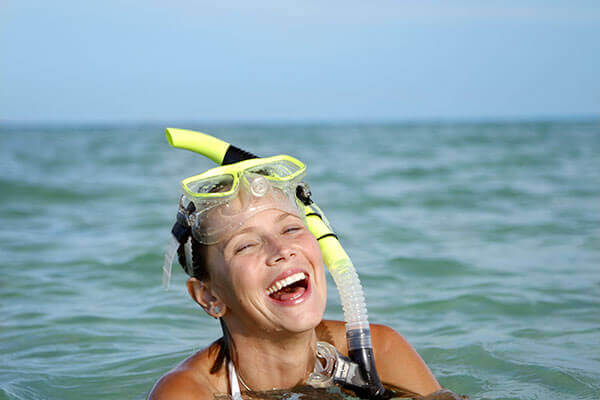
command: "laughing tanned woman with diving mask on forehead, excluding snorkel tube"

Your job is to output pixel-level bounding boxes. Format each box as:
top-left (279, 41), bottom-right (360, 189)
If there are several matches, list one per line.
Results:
top-left (149, 130), bottom-right (441, 400)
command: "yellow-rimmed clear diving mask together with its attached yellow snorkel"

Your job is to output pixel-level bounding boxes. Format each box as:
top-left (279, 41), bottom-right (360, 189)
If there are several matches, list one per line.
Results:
top-left (163, 128), bottom-right (393, 400)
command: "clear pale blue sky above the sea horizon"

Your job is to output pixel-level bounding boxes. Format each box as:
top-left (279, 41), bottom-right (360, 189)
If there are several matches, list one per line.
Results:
top-left (0, 0), bottom-right (600, 123)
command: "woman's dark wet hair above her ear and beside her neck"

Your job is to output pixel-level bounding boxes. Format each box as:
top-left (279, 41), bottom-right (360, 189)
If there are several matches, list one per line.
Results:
top-left (177, 235), bottom-right (235, 374)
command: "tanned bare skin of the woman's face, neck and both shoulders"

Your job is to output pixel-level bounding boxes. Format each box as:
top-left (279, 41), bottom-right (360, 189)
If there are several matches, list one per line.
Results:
top-left (150, 211), bottom-right (440, 400)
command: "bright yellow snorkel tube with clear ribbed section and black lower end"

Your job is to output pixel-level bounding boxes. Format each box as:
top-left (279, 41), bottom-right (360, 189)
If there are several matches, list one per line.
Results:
top-left (166, 128), bottom-right (392, 400)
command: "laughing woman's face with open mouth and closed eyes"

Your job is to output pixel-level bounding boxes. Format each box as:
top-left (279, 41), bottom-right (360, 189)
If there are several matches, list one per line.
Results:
top-left (207, 208), bottom-right (327, 333)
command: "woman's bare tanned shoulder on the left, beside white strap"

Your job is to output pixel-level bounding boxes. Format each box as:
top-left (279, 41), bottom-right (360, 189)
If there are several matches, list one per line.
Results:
top-left (148, 342), bottom-right (226, 400)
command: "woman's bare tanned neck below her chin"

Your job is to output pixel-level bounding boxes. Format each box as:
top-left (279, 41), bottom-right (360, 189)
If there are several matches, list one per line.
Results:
top-left (230, 330), bottom-right (317, 391)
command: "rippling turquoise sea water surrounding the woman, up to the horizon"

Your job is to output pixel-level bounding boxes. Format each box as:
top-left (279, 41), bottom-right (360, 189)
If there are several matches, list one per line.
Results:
top-left (0, 121), bottom-right (600, 399)
